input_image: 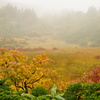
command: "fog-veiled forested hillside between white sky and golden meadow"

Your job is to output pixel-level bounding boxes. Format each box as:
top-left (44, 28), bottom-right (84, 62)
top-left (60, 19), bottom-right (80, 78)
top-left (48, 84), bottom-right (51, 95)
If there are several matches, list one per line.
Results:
top-left (0, 4), bottom-right (100, 48)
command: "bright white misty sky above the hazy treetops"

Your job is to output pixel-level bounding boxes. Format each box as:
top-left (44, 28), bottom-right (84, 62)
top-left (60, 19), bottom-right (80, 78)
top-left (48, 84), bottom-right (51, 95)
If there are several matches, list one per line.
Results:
top-left (0, 0), bottom-right (100, 16)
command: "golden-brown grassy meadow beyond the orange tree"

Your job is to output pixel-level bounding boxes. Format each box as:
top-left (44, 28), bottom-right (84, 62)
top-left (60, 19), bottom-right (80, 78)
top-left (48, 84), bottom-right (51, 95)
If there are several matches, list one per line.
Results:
top-left (22, 48), bottom-right (100, 82)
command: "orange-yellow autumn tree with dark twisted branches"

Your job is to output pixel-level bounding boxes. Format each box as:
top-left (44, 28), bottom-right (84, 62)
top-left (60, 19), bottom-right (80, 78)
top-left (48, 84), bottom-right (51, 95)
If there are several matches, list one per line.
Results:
top-left (0, 48), bottom-right (59, 92)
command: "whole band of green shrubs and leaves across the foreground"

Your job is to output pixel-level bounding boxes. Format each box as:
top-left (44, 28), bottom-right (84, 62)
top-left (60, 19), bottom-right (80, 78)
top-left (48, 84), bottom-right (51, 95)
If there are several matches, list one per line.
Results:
top-left (0, 79), bottom-right (100, 100)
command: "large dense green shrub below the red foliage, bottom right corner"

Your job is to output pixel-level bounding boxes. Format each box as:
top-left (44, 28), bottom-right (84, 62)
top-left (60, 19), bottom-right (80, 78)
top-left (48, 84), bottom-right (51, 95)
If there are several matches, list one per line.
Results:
top-left (64, 83), bottom-right (100, 100)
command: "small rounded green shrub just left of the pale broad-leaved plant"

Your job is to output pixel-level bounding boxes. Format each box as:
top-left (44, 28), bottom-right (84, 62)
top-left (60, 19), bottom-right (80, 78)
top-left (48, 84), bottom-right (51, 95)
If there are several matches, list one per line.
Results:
top-left (31, 86), bottom-right (49, 97)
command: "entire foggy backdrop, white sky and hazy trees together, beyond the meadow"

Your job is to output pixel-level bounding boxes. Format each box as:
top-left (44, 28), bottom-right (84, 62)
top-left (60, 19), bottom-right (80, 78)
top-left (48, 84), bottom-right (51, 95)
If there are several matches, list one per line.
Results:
top-left (0, 0), bottom-right (100, 48)
